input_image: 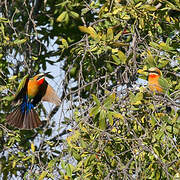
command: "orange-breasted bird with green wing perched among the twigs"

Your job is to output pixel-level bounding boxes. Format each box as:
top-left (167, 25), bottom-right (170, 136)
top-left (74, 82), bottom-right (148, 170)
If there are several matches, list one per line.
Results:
top-left (144, 67), bottom-right (170, 93)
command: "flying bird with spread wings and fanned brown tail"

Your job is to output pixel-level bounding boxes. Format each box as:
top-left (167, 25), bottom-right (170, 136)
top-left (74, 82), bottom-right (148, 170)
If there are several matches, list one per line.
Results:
top-left (6, 73), bottom-right (61, 130)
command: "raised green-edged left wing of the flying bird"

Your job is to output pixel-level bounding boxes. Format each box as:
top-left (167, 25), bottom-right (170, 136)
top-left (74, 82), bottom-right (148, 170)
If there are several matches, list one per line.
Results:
top-left (13, 74), bottom-right (29, 102)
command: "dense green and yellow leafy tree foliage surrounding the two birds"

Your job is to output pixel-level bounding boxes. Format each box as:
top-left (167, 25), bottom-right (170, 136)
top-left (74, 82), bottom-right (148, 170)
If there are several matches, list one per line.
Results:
top-left (0, 0), bottom-right (180, 180)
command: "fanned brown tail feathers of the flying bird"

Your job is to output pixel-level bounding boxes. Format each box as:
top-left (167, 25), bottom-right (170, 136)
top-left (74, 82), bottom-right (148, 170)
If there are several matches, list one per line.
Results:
top-left (6, 106), bottom-right (42, 129)
